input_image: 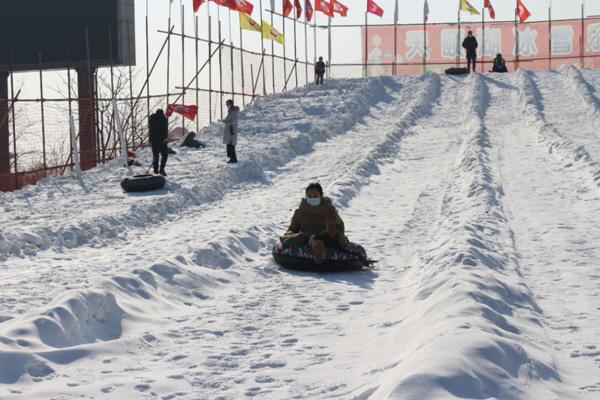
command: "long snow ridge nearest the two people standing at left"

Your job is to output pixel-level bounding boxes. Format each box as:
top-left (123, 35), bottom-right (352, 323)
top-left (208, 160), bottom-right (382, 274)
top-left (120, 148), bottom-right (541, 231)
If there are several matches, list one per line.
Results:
top-left (0, 77), bottom-right (386, 260)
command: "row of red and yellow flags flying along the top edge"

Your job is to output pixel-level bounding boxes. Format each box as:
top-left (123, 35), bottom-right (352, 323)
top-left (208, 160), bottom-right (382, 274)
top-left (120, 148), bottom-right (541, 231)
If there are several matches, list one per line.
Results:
top-left (169, 0), bottom-right (531, 24)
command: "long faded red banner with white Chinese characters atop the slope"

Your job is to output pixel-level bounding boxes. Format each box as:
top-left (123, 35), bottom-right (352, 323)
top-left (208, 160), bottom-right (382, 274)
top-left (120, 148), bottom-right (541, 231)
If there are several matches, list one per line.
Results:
top-left (362, 18), bottom-right (600, 75)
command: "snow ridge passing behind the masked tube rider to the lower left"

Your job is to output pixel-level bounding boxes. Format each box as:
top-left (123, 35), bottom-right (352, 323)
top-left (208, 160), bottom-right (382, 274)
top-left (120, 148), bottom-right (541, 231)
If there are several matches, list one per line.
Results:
top-left (0, 75), bottom-right (446, 394)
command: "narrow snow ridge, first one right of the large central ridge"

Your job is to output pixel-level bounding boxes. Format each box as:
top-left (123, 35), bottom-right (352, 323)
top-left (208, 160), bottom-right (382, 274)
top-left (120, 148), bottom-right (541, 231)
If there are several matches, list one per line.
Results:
top-left (517, 70), bottom-right (600, 188)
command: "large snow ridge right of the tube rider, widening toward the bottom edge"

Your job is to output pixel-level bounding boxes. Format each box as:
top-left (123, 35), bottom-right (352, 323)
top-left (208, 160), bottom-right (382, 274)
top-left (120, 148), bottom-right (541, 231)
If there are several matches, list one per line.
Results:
top-left (370, 74), bottom-right (560, 399)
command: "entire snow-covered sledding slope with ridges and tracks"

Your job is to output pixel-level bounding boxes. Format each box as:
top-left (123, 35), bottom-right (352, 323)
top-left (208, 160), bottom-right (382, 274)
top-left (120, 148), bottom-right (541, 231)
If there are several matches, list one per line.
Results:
top-left (0, 67), bottom-right (600, 400)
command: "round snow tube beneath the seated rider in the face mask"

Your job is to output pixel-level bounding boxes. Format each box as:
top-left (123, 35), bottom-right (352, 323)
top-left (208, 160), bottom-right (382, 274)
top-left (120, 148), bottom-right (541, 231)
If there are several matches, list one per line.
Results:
top-left (272, 240), bottom-right (371, 273)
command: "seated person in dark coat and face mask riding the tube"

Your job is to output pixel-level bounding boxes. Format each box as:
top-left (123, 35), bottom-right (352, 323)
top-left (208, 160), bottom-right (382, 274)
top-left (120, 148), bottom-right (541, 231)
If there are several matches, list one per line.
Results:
top-left (280, 183), bottom-right (349, 264)
